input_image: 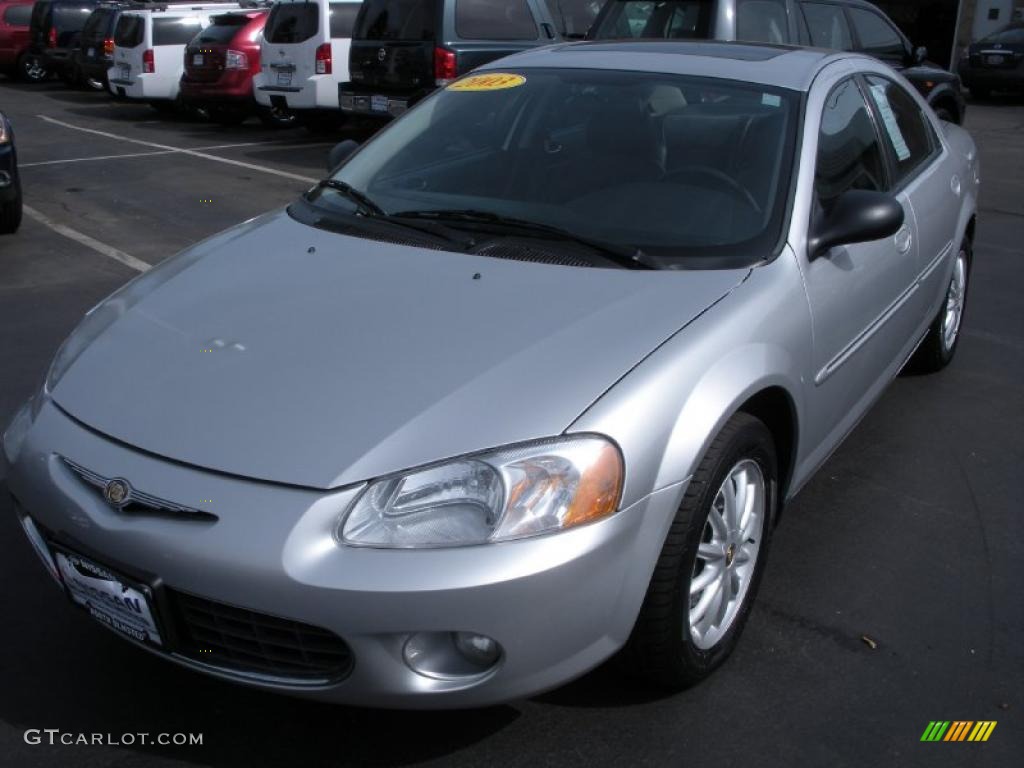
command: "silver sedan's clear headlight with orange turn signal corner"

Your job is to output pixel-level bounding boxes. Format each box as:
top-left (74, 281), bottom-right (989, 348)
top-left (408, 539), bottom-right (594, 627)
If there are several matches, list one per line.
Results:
top-left (339, 435), bottom-right (623, 548)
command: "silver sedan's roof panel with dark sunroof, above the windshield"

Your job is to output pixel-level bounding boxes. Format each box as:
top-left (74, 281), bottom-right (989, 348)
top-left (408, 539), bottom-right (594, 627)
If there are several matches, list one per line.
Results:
top-left (481, 39), bottom-right (851, 91)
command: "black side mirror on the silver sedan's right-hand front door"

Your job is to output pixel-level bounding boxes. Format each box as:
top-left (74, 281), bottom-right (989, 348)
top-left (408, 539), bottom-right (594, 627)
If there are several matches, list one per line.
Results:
top-left (807, 189), bottom-right (903, 259)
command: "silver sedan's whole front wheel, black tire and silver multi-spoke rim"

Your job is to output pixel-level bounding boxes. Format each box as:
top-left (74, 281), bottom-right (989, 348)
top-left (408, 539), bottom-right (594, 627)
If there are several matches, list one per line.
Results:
top-left (623, 413), bottom-right (778, 690)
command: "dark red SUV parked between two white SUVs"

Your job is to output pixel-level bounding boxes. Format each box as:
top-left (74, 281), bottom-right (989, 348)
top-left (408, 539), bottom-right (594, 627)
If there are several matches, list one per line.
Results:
top-left (181, 10), bottom-right (295, 127)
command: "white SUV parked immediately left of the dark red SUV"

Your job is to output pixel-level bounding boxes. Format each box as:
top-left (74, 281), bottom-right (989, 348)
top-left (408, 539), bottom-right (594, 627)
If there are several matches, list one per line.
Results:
top-left (106, 3), bottom-right (240, 109)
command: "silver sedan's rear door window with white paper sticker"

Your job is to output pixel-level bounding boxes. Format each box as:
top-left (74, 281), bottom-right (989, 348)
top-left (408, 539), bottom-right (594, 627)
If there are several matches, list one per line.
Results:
top-left (867, 75), bottom-right (938, 185)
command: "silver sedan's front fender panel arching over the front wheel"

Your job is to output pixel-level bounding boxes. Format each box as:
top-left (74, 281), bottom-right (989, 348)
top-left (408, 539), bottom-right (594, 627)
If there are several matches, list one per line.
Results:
top-left (569, 247), bottom-right (812, 506)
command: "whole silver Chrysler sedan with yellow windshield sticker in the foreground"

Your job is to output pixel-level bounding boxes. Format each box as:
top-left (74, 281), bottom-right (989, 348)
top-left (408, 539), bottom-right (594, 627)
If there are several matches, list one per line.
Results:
top-left (3, 42), bottom-right (979, 707)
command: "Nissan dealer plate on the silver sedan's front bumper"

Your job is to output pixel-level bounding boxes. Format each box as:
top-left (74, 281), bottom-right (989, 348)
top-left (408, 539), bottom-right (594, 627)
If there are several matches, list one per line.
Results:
top-left (55, 551), bottom-right (164, 645)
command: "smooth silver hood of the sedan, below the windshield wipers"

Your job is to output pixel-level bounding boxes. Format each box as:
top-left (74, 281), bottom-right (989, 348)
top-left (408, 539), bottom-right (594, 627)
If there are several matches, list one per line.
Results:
top-left (52, 207), bottom-right (748, 488)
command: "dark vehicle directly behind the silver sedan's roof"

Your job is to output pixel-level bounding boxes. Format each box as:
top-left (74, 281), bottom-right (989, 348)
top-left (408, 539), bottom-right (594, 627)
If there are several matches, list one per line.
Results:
top-left (588, 0), bottom-right (966, 124)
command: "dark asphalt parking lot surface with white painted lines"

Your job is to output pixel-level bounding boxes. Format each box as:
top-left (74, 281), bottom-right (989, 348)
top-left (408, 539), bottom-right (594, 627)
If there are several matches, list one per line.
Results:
top-left (0, 81), bottom-right (1024, 768)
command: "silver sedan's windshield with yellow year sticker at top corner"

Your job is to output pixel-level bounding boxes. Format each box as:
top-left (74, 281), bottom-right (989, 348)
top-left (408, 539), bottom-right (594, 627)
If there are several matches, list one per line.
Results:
top-left (308, 70), bottom-right (799, 265)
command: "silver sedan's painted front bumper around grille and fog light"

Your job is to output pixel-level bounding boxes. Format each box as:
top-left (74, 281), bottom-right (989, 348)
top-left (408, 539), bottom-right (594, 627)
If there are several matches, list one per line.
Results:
top-left (7, 401), bottom-right (685, 708)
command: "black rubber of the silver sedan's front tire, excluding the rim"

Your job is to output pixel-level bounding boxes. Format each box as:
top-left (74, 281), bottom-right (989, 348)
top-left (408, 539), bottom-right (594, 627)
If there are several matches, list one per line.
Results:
top-left (622, 413), bottom-right (778, 690)
